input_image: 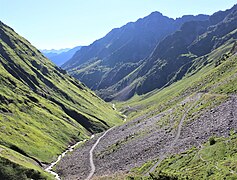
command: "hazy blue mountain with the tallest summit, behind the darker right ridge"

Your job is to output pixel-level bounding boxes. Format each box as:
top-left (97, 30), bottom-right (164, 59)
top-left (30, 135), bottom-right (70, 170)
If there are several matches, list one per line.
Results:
top-left (62, 12), bottom-right (208, 91)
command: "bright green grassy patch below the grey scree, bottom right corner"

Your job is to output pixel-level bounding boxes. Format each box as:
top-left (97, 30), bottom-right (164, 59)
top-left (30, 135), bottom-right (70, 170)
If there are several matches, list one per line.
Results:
top-left (147, 134), bottom-right (237, 179)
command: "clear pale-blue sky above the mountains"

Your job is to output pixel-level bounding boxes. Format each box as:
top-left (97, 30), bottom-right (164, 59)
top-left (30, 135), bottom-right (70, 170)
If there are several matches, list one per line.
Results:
top-left (0, 0), bottom-right (237, 49)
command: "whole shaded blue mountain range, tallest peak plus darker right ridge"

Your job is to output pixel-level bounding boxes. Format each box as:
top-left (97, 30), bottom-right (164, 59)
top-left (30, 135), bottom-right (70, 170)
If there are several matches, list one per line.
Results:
top-left (62, 6), bottom-right (237, 101)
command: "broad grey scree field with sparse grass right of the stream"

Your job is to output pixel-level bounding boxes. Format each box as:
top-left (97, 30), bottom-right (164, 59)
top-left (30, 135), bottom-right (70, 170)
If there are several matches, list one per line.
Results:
top-left (57, 93), bottom-right (237, 180)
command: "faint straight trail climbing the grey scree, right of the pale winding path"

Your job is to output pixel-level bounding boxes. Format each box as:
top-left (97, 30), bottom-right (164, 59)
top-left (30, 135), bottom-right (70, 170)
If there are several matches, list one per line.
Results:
top-left (145, 93), bottom-right (201, 176)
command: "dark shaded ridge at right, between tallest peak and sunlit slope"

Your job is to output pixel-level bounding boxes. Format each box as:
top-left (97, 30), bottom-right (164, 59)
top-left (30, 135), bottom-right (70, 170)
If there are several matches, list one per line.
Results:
top-left (101, 3), bottom-right (237, 101)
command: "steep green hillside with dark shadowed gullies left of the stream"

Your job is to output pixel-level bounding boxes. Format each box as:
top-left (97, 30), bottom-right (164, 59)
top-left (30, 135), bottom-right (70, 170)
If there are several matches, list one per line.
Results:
top-left (0, 22), bottom-right (122, 179)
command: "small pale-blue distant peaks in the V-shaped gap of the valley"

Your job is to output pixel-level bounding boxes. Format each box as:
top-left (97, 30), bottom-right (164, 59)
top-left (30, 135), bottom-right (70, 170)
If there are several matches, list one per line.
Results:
top-left (41, 46), bottom-right (81, 66)
